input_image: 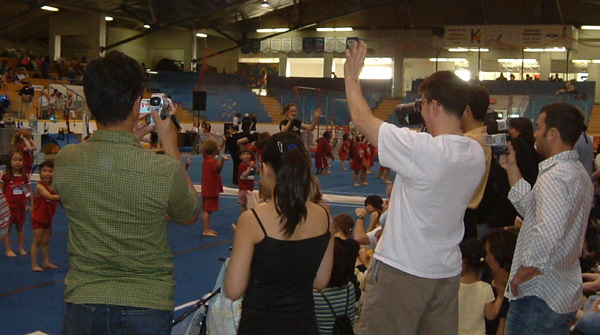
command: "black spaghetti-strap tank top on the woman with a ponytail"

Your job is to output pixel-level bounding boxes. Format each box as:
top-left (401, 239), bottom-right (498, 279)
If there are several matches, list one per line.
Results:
top-left (239, 209), bottom-right (331, 334)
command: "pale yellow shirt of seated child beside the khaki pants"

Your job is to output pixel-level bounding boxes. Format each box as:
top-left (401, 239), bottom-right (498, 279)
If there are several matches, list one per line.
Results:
top-left (458, 281), bottom-right (494, 335)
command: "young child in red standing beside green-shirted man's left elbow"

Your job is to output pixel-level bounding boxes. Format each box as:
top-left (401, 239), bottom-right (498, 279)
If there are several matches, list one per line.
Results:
top-left (31, 161), bottom-right (60, 272)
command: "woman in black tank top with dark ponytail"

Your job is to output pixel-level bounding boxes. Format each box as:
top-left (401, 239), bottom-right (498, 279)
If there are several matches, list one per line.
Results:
top-left (225, 132), bottom-right (333, 335)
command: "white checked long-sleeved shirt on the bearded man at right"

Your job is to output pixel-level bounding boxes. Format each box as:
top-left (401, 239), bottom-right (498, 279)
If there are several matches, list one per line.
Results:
top-left (505, 150), bottom-right (593, 314)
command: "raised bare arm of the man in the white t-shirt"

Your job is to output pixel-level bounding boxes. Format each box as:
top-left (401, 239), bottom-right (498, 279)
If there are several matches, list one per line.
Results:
top-left (344, 41), bottom-right (383, 147)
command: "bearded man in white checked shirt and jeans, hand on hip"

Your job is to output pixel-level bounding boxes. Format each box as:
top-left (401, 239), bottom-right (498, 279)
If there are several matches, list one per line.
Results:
top-left (500, 103), bottom-right (593, 335)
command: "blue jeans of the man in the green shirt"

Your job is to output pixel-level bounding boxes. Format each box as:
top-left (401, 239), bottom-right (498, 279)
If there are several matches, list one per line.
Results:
top-left (62, 303), bottom-right (173, 335)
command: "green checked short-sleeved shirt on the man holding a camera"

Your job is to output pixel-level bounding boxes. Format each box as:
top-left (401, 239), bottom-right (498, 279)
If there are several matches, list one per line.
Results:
top-left (53, 130), bottom-right (200, 310)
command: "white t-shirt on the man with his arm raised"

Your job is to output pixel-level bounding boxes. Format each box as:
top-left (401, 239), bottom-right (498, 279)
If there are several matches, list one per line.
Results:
top-left (374, 123), bottom-right (485, 279)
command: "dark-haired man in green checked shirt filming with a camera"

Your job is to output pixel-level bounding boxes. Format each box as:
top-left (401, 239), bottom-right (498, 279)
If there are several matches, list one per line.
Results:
top-left (53, 51), bottom-right (200, 335)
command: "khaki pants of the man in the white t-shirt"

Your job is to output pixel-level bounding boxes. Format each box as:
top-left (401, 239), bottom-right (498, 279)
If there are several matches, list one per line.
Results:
top-left (359, 260), bottom-right (460, 335)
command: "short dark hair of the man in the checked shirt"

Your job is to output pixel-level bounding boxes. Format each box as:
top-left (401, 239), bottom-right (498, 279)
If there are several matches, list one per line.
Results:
top-left (541, 102), bottom-right (585, 146)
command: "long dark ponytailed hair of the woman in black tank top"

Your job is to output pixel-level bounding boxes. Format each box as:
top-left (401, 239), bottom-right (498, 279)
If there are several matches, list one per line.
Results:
top-left (262, 132), bottom-right (311, 236)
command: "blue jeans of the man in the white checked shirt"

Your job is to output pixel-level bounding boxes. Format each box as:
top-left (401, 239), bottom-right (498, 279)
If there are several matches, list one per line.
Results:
top-left (505, 296), bottom-right (576, 335)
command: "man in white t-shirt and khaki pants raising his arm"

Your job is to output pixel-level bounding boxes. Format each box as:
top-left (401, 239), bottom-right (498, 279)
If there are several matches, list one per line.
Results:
top-left (344, 41), bottom-right (485, 335)
